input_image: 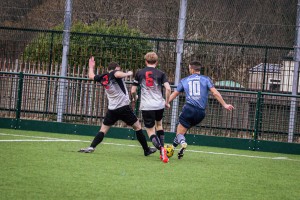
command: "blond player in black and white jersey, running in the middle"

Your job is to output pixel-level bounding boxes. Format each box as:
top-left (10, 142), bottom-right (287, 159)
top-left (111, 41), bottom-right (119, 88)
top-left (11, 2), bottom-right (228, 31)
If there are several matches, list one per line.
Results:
top-left (131, 52), bottom-right (171, 162)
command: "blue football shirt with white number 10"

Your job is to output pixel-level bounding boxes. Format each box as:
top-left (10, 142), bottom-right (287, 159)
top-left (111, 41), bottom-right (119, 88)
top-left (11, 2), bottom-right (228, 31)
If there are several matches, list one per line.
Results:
top-left (176, 74), bottom-right (214, 109)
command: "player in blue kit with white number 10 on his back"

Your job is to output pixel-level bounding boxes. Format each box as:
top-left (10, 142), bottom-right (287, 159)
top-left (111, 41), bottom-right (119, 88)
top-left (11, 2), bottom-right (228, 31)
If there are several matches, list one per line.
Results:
top-left (169, 61), bottom-right (234, 159)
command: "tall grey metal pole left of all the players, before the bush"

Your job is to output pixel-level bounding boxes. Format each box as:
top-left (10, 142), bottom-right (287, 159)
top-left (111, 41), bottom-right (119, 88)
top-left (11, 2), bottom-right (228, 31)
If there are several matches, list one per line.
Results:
top-left (57, 0), bottom-right (72, 122)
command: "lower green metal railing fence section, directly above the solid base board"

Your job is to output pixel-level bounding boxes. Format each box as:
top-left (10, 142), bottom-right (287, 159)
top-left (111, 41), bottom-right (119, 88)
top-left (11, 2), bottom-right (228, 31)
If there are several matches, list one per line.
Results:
top-left (0, 72), bottom-right (300, 143)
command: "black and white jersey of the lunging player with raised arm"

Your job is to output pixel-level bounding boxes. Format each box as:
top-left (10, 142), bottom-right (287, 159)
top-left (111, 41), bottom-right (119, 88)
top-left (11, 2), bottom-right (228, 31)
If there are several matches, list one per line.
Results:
top-left (94, 70), bottom-right (130, 110)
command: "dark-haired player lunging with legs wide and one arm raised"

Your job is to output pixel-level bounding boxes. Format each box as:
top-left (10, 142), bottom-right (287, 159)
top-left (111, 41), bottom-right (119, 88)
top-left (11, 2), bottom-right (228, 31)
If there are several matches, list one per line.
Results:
top-left (79, 57), bottom-right (156, 156)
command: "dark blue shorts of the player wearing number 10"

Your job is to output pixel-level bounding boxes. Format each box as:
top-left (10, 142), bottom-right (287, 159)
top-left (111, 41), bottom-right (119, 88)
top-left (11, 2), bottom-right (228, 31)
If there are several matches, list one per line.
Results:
top-left (179, 104), bottom-right (205, 129)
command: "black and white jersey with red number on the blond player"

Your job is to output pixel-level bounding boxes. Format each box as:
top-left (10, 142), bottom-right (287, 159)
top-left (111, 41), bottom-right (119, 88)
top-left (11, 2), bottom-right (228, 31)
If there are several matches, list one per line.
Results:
top-left (133, 67), bottom-right (168, 110)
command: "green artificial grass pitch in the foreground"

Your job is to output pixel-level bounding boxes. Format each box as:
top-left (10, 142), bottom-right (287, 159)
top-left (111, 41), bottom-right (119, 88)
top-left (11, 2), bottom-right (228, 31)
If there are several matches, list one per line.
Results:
top-left (0, 129), bottom-right (300, 200)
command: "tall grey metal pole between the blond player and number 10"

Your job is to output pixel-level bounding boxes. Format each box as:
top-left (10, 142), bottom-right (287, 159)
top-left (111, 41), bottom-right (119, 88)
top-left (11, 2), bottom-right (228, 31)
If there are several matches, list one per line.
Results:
top-left (171, 0), bottom-right (187, 132)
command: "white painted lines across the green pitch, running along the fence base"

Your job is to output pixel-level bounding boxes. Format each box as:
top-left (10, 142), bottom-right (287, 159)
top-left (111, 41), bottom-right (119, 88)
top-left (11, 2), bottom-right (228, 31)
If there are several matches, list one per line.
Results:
top-left (0, 133), bottom-right (300, 162)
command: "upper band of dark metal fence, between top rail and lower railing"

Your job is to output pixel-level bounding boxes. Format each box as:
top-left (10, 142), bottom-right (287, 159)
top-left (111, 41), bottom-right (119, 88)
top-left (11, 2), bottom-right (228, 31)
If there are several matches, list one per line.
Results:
top-left (0, 27), bottom-right (300, 93)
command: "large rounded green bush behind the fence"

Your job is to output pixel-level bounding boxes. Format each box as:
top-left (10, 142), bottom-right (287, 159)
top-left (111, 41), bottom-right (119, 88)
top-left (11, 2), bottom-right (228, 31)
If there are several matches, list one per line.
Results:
top-left (23, 20), bottom-right (153, 70)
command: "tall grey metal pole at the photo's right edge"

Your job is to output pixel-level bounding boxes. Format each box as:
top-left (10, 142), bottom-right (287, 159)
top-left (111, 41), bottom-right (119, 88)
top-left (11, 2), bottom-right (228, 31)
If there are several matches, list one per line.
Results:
top-left (288, 0), bottom-right (300, 142)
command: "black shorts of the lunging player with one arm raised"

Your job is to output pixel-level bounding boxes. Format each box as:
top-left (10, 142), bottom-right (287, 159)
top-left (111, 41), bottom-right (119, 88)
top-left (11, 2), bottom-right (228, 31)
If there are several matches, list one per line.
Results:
top-left (103, 105), bottom-right (138, 126)
